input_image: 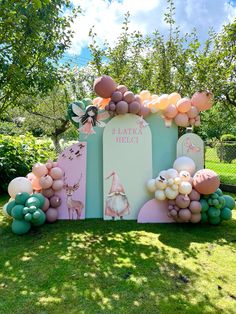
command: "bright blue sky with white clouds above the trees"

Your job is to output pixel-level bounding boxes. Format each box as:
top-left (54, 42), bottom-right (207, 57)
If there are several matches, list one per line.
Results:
top-left (61, 0), bottom-right (236, 66)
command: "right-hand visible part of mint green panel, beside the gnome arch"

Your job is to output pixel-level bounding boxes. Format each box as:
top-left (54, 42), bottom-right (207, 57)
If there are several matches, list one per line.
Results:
top-left (145, 114), bottom-right (178, 177)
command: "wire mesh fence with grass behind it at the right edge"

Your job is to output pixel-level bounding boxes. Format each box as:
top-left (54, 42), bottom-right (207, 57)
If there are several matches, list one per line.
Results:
top-left (205, 141), bottom-right (236, 192)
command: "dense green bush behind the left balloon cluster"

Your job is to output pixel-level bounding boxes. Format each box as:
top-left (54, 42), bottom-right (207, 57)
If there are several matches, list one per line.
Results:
top-left (0, 134), bottom-right (56, 191)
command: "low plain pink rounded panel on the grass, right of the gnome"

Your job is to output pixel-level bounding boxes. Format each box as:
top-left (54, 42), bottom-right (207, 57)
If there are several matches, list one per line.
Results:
top-left (138, 199), bottom-right (175, 223)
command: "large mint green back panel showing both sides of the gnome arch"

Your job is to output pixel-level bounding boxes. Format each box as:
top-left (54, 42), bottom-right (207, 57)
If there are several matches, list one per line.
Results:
top-left (80, 114), bottom-right (178, 218)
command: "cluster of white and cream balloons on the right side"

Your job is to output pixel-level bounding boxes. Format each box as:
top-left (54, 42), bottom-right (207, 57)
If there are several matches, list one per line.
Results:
top-left (147, 156), bottom-right (195, 201)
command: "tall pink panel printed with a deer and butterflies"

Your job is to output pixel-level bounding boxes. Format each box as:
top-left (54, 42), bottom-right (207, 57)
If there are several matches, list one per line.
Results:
top-left (58, 142), bottom-right (87, 220)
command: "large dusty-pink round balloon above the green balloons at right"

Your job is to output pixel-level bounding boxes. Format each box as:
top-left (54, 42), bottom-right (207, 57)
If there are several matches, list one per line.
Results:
top-left (193, 169), bottom-right (220, 194)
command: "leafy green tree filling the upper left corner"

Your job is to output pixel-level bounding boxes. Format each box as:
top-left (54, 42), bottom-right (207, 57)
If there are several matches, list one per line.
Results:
top-left (0, 0), bottom-right (78, 117)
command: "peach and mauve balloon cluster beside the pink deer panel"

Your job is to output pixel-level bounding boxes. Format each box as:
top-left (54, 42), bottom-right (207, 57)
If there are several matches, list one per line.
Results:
top-left (27, 160), bottom-right (64, 223)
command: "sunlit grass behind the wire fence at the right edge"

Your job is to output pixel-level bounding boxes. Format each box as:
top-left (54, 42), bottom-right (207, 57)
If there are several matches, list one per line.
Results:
top-left (205, 147), bottom-right (236, 185)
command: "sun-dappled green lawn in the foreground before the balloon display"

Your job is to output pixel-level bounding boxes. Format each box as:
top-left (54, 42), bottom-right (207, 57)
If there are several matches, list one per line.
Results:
top-left (0, 194), bottom-right (236, 314)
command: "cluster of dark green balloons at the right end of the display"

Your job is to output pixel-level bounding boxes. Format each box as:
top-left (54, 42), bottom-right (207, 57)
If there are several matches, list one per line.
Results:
top-left (200, 188), bottom-right (235, 225)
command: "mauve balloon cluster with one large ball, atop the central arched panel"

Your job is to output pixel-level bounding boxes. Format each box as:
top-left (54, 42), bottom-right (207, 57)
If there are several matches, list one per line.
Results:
top-left (93, 75), bottom-right (150, 117)
